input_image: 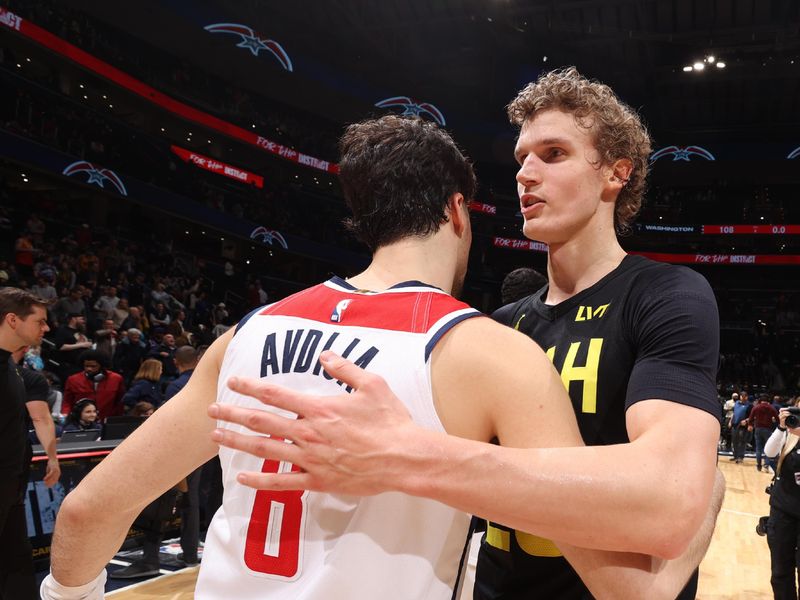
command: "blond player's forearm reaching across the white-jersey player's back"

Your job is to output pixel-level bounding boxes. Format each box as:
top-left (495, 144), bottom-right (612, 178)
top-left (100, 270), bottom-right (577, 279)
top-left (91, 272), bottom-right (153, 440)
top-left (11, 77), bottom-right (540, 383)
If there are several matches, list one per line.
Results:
top-left (406, 433), bottom-right (713, 558)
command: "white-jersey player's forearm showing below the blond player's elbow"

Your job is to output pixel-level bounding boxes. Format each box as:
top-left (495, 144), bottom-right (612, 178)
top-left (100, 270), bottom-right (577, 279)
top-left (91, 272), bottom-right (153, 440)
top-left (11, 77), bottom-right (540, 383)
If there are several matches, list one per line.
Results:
top-left (557, 470), bottom-right (725, 600)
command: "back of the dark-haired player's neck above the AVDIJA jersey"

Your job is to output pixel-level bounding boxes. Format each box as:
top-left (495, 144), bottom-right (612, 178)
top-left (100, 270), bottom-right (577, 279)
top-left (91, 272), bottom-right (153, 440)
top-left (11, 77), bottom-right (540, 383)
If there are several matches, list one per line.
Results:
top-left (348, 238), bottom-right (456, 294)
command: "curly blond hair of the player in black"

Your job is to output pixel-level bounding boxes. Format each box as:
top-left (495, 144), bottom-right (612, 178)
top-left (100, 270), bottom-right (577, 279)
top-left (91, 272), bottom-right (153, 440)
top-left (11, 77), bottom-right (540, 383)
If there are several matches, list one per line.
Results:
top-left (507, 67), bottom-right (652, 234)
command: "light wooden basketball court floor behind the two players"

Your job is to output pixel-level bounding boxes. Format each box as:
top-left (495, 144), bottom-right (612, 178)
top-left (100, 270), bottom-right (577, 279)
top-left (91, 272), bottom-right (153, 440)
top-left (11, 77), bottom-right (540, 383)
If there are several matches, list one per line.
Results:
top-left (95, 456), bottom-right (772, 600)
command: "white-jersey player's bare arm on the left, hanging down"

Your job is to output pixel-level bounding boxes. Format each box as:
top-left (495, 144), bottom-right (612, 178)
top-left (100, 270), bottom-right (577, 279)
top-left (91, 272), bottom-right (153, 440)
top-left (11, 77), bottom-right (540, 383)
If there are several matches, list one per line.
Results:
top-left (51, 329), bottom-right (234, 586)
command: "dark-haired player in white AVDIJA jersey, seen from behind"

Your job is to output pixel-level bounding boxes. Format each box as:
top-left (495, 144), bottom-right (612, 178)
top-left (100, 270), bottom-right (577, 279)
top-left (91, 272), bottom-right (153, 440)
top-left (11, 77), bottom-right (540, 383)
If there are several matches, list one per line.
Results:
top-left (42, 117), bottom-right (713, 600)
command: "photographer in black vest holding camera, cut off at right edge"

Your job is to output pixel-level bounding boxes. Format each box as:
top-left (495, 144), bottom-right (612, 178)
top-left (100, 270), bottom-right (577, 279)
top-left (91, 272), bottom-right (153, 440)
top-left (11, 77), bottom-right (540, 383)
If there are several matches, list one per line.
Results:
top-left (764, 398), bottom-right (800, 600)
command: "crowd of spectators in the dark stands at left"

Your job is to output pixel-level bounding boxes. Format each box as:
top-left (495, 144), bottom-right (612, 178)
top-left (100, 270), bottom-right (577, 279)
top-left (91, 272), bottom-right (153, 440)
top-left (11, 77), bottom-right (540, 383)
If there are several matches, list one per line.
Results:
top-left (0, 197), bottom-right (268, 429)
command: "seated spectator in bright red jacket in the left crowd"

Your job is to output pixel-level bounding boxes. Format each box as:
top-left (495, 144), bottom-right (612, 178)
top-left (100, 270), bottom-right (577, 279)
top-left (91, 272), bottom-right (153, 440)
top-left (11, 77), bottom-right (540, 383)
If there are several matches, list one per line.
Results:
top-left (61, 350), bottom-right (125, 421)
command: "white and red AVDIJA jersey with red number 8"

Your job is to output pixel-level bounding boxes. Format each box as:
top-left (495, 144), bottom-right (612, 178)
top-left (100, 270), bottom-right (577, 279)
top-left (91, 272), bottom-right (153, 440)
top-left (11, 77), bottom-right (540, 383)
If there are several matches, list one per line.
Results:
top-left (196, 278), bottom-right (480, 600)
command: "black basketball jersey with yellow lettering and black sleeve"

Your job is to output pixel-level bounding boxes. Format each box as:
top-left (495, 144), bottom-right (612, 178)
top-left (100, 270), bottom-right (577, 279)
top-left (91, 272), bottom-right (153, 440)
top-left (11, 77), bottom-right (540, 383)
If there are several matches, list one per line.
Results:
top-left (484, 255), bottom-right (718, 600)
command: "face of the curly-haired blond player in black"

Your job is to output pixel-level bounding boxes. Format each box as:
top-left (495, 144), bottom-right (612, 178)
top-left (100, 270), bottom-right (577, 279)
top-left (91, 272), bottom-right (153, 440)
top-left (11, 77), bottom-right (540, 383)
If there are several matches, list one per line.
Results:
top-left (514, 109), bottom-right (617, 245)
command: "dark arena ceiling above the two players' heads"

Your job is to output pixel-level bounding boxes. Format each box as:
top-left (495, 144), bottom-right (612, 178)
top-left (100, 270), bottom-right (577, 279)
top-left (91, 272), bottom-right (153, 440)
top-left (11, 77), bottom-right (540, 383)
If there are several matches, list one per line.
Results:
top-left (70, 0), bottom-right (800, 162)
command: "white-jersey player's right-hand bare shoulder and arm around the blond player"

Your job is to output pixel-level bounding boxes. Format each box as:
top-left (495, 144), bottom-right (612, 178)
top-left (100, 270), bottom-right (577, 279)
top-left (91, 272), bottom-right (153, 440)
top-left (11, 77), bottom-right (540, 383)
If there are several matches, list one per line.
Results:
top-left (432, 319), bottom-right (725, 600)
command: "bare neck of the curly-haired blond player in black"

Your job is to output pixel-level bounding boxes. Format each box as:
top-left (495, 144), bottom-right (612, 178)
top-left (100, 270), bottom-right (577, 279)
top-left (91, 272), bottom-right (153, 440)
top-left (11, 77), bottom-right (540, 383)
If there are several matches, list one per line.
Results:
top-left (545, 229), bottom-right (625, 305)
